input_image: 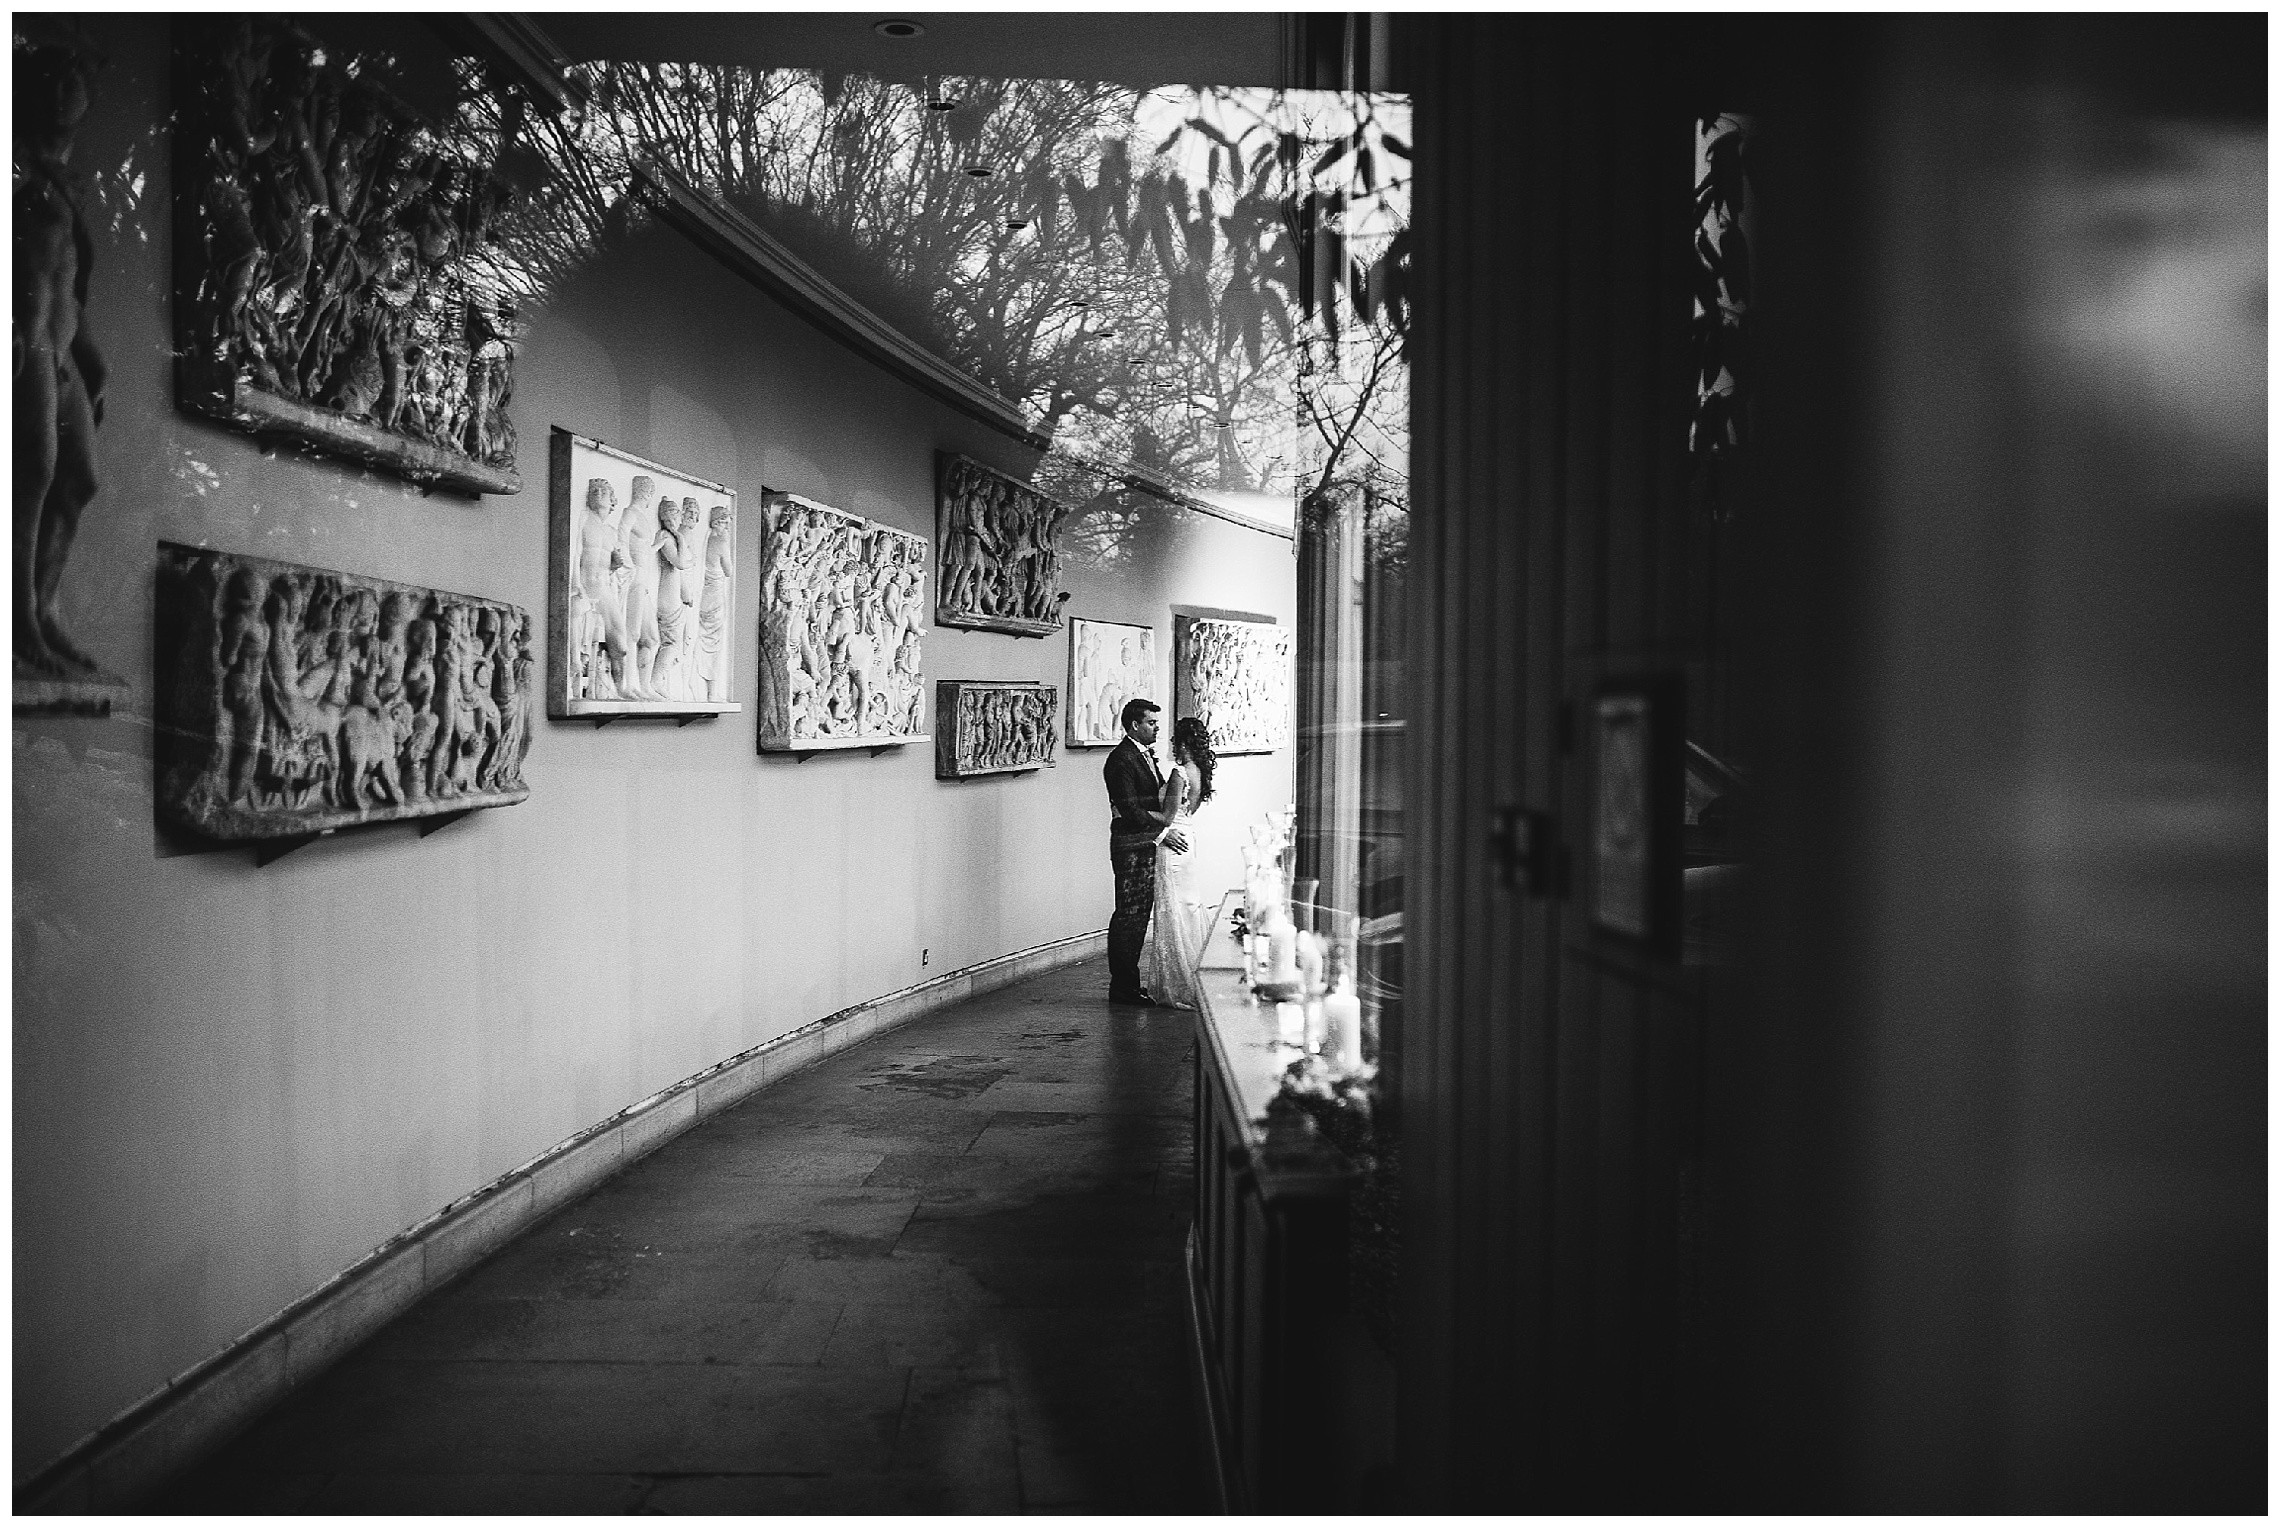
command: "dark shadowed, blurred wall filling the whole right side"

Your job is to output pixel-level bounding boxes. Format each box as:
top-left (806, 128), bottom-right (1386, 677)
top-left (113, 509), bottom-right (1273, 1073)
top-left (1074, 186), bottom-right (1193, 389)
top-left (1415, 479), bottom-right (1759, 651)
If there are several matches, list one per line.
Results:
top-left (1400, 16), bottom-right (2269, 1512)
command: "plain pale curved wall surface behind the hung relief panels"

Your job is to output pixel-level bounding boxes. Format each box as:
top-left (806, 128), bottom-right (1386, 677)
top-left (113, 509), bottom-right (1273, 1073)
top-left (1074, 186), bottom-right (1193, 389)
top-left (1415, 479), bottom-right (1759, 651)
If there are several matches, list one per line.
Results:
top-left (14, 18), bottom-right (1295, 1480)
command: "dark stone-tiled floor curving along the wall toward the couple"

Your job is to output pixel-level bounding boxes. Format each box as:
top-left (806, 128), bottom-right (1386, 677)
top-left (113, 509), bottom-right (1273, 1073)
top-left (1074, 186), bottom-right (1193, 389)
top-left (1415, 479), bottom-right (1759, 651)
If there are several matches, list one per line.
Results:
top-left (150, 960), bottom-right (1208, 1512)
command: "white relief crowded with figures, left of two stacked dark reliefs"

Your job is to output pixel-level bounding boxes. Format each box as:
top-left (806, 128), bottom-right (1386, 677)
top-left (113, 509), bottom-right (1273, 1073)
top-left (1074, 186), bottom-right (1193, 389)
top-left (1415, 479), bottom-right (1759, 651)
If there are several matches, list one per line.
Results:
top-left (759, 493), bottom-right (928, 753)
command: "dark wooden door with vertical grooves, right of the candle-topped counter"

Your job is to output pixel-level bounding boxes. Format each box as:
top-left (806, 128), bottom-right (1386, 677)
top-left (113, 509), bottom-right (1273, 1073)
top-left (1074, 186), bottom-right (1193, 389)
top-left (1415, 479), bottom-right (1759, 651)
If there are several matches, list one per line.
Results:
top-left (1402, 18), bottom-right (1703, 1512)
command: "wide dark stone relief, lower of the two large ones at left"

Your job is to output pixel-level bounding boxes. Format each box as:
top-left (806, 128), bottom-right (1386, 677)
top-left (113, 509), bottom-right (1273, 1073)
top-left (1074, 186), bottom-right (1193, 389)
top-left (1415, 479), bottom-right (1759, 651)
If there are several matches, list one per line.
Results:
top-left (157, 541), bottom-right (536, 842)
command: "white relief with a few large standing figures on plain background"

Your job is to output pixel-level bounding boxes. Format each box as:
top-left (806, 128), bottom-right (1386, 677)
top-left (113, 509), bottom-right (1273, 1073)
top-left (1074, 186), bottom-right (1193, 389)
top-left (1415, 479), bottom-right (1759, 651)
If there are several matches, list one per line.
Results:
top-left (547, 429), bottom-right (743, 718)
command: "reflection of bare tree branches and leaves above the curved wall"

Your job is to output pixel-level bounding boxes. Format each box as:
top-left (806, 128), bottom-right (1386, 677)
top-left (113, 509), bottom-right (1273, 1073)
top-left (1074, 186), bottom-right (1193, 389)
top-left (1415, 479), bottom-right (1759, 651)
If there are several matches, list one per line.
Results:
top-left (430, 62), bottom-right (1409, 515)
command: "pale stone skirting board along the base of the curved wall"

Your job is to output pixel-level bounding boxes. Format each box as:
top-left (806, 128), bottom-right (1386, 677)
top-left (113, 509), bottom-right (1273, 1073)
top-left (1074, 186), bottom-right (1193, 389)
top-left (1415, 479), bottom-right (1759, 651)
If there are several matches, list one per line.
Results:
top-left (16, 930), bottom-right (1108, 1512)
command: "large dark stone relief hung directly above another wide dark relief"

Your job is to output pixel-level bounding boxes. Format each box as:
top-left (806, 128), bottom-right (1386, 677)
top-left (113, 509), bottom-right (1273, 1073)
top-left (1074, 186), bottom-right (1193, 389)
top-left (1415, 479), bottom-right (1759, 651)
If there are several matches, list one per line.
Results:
top-left (176, 16), bottom-right (522, 493)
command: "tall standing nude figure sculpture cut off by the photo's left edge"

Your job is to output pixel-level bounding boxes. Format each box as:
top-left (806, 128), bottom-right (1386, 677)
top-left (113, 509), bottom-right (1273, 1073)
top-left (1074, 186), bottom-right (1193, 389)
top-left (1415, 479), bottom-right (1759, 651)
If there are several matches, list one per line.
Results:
top-left (14, 23), bottom-right (125, 714)
